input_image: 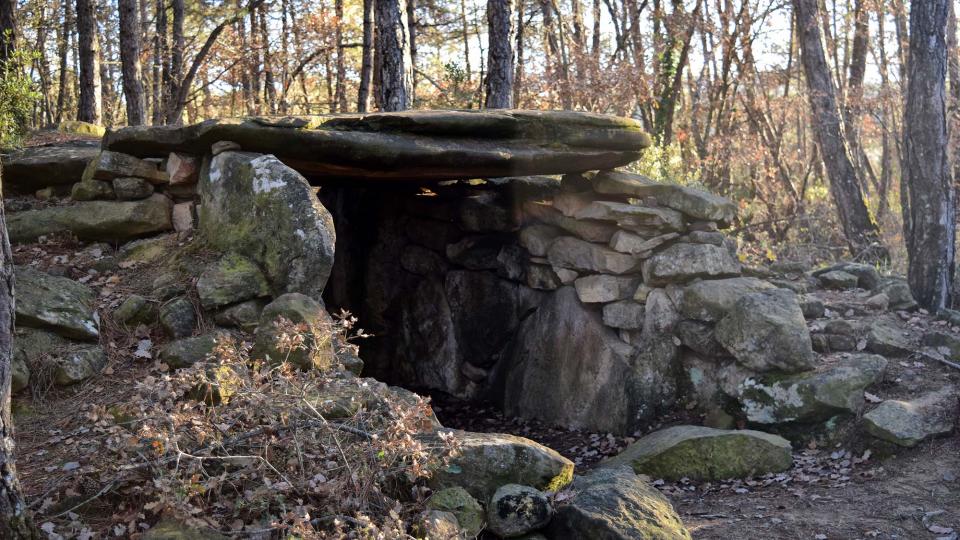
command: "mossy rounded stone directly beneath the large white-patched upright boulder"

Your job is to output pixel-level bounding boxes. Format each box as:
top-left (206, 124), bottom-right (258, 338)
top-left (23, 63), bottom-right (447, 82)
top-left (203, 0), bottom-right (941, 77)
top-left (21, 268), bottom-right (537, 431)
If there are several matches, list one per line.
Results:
top-left (197, 253), bottom-right (270, 309)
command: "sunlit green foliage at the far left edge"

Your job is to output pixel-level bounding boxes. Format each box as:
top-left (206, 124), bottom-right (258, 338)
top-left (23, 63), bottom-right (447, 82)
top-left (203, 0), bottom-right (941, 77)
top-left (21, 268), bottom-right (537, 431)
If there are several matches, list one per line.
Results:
top-left (0, 50), bottom-right (40, 147)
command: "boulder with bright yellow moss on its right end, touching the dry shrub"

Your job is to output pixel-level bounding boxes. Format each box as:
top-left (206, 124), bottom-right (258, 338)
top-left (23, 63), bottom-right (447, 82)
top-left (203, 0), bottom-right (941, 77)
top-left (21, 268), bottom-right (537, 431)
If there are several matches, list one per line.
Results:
top-left (430, 431), bottom-right (573, 501)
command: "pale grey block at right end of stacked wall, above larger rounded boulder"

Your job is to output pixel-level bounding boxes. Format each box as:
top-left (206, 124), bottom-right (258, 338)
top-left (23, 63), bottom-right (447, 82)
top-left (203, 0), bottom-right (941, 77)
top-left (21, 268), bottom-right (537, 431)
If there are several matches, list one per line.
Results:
top-left (643, 244), bottom-right (740, 287)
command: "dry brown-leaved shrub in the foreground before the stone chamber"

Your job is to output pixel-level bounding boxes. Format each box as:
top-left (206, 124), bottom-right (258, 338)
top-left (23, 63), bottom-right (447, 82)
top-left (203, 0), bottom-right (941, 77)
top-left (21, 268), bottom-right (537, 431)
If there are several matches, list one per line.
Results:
top-left (92, 317), bottom-right (456, 538)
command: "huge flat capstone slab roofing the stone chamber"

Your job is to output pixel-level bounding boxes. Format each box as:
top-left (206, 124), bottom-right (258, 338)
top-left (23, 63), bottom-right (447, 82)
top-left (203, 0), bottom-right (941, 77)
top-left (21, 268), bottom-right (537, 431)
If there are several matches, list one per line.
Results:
top-left (104, 110), bottom-right (650, 180)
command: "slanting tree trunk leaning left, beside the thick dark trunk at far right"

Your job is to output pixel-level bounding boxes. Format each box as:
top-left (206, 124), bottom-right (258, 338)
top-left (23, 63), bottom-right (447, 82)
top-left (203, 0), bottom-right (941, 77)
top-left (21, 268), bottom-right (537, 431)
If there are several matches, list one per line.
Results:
top-left (794, 0), bottom-right (889, 261)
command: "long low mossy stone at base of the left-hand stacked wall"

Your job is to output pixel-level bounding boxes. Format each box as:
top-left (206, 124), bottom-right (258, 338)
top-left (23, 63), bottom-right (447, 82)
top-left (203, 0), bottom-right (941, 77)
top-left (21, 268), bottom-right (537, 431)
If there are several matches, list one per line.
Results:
top-left (7, 194), bottom-right (173, 242)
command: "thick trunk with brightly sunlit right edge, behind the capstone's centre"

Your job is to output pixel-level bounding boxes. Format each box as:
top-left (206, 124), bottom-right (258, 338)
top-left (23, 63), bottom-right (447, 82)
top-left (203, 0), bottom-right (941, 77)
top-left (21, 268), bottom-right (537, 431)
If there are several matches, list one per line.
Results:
top-left (376, 0), bottom-right (411, 111)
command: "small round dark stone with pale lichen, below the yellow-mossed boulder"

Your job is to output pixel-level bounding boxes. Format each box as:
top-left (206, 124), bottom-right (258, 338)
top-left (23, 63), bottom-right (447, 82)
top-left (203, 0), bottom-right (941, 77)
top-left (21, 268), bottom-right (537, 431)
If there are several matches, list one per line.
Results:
top-left (487, 484), bottom-right (553, 538)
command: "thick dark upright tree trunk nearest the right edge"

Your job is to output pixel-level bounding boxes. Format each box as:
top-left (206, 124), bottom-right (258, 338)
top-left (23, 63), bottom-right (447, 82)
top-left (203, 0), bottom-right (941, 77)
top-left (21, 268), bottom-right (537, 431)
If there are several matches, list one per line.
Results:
top-left (902, 0), bottom-right (956, 313)
